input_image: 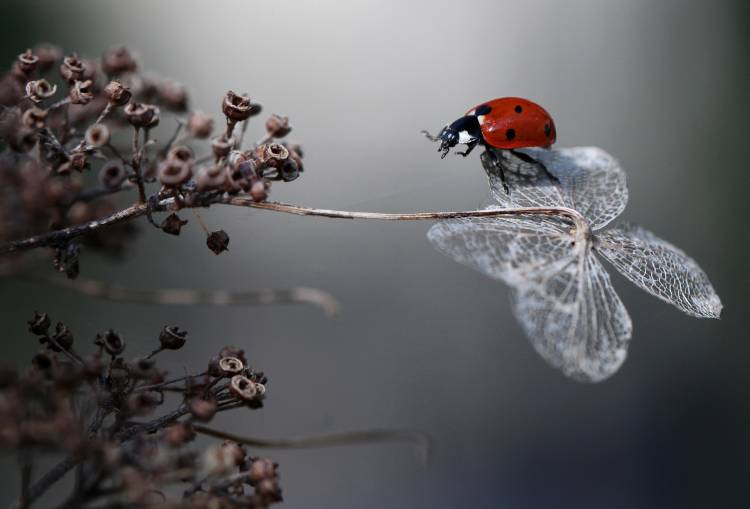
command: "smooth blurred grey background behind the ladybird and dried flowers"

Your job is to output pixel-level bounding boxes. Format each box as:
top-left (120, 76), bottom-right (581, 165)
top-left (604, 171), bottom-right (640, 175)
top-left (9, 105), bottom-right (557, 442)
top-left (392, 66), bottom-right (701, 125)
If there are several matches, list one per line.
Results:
top-left (0, 0), bottom-right (750, 508)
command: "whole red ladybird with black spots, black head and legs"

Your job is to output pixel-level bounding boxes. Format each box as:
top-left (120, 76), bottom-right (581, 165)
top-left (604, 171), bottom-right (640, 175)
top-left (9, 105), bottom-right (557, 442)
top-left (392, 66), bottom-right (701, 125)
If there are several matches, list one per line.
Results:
top-left (423, 97), bottom-right (557, 191)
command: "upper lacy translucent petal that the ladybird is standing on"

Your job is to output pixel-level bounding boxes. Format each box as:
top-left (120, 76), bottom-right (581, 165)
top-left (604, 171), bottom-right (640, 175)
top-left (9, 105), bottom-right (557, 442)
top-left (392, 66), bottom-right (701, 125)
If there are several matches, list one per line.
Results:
top-left (482, 147), bottom-right (628, 230)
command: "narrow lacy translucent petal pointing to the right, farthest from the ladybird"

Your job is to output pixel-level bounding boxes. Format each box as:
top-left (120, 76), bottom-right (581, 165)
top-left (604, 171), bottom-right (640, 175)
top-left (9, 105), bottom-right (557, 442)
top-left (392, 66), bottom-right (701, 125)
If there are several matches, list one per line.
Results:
top-left (595, 225), bottom-right (722, 318)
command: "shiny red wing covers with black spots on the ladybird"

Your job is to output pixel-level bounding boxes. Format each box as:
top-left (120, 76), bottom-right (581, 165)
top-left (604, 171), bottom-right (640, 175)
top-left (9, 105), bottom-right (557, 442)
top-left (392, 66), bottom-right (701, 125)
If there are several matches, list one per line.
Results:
top-left (466, 97), bottom-right (557, 149)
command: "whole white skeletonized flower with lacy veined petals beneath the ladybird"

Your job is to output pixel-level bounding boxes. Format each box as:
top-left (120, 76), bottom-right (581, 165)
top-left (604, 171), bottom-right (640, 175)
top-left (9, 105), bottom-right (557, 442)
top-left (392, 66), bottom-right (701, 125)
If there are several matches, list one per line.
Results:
top-left (427, 147), bottom-right (722, 382)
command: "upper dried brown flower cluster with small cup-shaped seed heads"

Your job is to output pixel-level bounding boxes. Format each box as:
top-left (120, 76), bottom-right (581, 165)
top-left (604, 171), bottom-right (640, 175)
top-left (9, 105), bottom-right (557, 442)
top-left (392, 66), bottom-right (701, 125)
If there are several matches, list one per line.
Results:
top-left (0, 44), bottom-right (303, 277)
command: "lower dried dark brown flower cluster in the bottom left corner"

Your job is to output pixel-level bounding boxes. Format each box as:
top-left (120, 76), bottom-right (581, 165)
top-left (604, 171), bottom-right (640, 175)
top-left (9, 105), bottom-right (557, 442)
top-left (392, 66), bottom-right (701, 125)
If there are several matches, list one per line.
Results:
top-left (0, 313), bottom-right (281, 509)
